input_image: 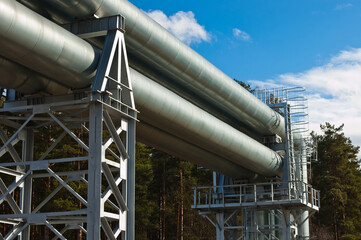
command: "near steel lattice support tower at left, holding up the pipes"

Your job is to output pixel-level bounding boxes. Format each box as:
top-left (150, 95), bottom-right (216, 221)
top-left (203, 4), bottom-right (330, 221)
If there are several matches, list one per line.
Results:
top-left (0, 16), bottom-right (137, 240)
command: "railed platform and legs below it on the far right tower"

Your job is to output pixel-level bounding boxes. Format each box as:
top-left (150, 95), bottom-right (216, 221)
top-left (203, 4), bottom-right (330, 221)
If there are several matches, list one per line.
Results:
top-left (192, 182), bottom-right (320, 240)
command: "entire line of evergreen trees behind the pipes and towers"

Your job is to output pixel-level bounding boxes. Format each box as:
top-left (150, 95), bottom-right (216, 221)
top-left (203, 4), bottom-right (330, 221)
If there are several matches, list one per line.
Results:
top-left (0, 93), bottom-right (361, 240)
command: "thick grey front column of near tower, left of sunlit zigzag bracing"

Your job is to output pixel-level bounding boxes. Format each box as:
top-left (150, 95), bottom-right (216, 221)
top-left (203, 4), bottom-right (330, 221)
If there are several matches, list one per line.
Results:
top-left (87, 102), bottom-right (104, 240)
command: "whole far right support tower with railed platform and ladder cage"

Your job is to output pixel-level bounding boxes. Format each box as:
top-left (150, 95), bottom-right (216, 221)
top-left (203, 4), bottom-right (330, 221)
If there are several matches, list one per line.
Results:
top-left (192, 88), bottom-right (320, 240)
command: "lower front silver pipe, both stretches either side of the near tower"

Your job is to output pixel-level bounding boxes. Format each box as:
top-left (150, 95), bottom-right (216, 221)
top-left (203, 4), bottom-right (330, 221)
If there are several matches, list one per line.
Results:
top-left (0, 0), bottom-right (282, 176)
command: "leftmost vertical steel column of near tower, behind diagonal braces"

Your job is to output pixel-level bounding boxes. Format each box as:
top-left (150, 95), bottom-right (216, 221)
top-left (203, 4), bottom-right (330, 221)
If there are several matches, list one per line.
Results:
top-left (21, 128), bottom-right (34, 240)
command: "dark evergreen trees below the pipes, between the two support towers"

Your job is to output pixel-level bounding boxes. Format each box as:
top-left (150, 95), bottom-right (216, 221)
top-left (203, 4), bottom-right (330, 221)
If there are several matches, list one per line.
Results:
top-left (136, 144), bottom-right (215, 240)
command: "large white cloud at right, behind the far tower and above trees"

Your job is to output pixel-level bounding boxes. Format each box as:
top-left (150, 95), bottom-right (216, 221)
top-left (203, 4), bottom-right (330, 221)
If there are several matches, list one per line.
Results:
top-left (248, 48), bottom-right (361, 151)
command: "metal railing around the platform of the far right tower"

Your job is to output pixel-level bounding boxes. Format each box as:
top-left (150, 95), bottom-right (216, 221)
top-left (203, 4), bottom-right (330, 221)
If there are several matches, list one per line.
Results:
top-left (192, 181), bottom-right (320, 210)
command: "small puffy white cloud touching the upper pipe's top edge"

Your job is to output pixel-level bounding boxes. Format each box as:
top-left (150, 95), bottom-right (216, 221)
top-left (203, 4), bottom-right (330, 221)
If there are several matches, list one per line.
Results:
top-left (147, 10), bottom-right (211, 45)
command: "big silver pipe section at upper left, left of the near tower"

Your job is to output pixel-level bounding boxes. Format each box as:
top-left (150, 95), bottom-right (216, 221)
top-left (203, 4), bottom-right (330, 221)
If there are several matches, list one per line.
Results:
top-left (0, 0), bottom-right (100, 88)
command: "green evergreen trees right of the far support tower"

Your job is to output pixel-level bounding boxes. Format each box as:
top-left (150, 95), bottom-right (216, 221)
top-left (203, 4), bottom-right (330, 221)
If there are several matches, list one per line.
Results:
top-left (313, 123), bottom-right (361, 239)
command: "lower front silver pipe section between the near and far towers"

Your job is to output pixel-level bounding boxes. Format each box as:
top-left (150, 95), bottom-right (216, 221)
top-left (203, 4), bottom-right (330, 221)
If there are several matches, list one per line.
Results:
top-left (130, 69), bottom-right (282, 176)
